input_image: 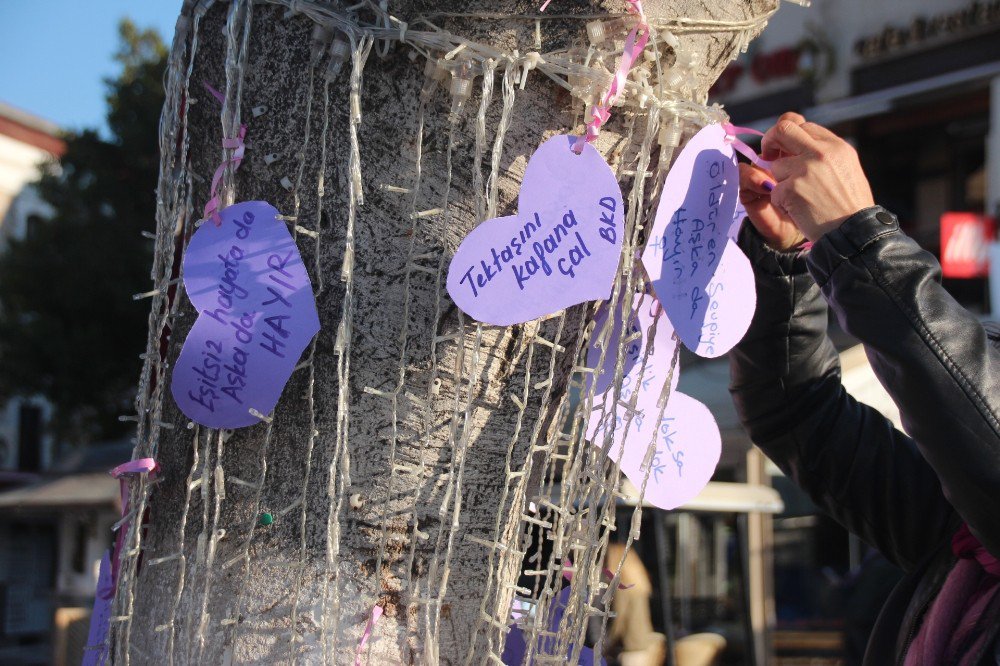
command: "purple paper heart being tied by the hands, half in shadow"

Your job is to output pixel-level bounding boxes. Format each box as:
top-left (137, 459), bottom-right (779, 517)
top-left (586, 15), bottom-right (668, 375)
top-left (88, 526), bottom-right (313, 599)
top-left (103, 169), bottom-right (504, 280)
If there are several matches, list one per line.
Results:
top-left (642, 124), bottom-right (757, 358)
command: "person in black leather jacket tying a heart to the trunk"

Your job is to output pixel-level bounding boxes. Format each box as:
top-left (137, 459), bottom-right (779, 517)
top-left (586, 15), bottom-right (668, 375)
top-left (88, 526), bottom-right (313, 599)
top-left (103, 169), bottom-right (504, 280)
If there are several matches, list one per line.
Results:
top-left (730, 114), bottom-right (1000, 666)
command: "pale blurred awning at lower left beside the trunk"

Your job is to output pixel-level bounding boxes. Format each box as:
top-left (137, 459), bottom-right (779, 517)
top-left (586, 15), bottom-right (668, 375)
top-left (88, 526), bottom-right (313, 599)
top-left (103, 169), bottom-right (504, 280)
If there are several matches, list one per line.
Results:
top-left (0, 472), bottom-right (121, 511)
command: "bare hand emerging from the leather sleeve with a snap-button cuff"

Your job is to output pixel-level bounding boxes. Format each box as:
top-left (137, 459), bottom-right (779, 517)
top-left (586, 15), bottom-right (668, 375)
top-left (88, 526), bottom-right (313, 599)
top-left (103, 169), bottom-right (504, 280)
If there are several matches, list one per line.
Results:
top-left (760, 113), bottom-right (875, 241)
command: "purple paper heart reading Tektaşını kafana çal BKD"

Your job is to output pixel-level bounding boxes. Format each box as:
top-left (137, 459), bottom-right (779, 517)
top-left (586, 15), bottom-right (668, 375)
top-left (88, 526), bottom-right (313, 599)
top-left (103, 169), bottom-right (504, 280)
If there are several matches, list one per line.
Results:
top-left (448, 134), bottom-right (624, 326)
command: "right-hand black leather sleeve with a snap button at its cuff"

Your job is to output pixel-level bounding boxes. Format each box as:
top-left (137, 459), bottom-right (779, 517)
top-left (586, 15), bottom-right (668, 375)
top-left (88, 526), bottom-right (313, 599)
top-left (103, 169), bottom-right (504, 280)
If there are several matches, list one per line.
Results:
top-left (807, 206), bottom-right (1000, 556)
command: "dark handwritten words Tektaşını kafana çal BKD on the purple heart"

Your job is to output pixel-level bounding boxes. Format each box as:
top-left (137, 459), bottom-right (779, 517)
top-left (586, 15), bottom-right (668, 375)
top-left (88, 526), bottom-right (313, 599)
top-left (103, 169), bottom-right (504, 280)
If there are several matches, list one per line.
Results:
top-left (459, 197), bottom-right (618, 297)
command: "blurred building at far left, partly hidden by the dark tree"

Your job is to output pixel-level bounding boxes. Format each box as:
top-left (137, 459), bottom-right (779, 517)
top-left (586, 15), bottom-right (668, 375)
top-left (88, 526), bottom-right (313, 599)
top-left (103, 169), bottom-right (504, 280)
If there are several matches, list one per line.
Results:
top-left (0, 103), bottom-right (122, 664)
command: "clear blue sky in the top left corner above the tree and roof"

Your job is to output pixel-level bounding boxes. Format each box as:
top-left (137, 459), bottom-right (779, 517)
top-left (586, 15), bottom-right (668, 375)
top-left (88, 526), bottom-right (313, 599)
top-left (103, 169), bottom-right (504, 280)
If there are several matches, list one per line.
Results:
top-left (0, 0), bottom-right (182, 136)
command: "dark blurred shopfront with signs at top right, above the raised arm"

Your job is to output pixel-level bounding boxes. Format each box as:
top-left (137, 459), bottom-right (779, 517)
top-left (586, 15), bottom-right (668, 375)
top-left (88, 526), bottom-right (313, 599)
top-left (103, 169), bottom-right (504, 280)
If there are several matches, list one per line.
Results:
top-left (712, 0), bottom-right (1000, 310)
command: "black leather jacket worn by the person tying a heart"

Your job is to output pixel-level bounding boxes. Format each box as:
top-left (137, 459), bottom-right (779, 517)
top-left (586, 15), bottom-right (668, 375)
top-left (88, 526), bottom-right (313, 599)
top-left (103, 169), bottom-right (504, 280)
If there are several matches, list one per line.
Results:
top-left (730, 206), bottom-right (1000, 666)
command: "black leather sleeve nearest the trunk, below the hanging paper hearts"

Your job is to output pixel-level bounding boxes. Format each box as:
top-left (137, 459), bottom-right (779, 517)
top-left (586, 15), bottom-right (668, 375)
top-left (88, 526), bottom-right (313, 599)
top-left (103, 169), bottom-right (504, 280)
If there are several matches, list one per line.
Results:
top-left (730, 219), bottom-right (956, 570)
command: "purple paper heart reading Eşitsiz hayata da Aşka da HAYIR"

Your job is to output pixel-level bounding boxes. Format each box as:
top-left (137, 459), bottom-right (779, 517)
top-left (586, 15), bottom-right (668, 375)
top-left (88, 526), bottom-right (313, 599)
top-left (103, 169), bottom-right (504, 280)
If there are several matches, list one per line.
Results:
top-left (170, 201), bottom-right (319, 428)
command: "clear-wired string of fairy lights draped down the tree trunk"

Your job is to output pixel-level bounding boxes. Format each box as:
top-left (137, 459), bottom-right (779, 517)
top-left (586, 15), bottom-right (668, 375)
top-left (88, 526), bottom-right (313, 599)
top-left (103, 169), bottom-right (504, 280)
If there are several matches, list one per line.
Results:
top-left (110, 0), bottom-right (777, 664)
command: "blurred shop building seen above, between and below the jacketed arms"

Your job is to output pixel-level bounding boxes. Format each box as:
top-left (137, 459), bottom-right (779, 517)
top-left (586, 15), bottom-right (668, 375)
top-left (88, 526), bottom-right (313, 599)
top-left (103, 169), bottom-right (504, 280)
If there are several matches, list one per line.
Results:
top-left (710, 0), bottom-right (1000, 664)
